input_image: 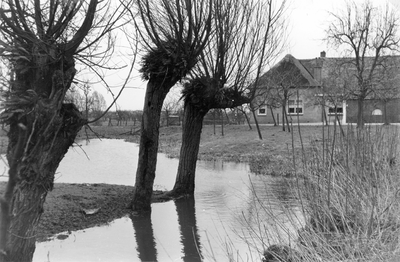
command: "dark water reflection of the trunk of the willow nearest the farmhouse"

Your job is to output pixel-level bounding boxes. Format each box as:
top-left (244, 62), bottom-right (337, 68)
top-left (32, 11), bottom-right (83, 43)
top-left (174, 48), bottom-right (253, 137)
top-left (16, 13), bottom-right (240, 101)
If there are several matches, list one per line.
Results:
top-left (174, 196), bottom-right (203, 262)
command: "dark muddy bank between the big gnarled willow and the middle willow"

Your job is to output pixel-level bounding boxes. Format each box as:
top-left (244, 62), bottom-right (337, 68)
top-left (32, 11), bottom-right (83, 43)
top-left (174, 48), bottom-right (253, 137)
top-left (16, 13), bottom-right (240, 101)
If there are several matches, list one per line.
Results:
top-left (0, 182), bottom-right (166, 241)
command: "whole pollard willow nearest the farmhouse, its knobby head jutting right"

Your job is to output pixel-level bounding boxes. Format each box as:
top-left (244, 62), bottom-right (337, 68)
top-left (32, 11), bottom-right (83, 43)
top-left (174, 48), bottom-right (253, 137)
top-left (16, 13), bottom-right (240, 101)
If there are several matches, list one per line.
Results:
top-left (167, 0), bottom-right (286, 196)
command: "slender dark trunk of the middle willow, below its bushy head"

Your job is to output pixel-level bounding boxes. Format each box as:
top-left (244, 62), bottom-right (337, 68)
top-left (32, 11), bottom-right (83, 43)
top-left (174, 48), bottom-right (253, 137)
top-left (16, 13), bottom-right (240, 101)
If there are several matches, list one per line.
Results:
top-left (131, 79), bottom-right (176, 210)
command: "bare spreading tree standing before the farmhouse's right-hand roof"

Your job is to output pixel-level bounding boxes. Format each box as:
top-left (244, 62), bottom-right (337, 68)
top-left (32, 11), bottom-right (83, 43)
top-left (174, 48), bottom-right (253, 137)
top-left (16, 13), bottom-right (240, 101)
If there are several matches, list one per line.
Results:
top-left (326, 1), bottom-right (400, 127)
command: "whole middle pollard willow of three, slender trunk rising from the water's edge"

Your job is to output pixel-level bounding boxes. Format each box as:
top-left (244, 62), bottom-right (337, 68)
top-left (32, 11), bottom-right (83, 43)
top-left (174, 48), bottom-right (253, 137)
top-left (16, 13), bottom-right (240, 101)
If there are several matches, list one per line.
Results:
top-left (131, 0), bottom-right (212, 210)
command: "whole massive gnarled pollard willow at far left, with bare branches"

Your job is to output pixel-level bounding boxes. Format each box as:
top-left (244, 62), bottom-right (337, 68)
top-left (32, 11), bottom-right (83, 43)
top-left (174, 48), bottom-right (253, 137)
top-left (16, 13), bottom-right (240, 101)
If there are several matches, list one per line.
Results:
top-left (0, 0), bottom-right (128, 261)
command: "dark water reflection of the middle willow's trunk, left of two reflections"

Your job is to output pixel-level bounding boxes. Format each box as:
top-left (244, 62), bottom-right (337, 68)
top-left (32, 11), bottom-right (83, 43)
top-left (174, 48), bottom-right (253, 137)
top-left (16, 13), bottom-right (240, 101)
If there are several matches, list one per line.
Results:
top-left (130, 211), bottom-right (157, 261)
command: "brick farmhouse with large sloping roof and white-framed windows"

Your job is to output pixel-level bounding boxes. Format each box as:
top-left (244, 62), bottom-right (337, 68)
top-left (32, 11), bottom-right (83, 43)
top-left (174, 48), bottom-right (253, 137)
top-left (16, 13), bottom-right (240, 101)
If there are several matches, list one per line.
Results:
top-left (253, 52), bottom-right (400, 124)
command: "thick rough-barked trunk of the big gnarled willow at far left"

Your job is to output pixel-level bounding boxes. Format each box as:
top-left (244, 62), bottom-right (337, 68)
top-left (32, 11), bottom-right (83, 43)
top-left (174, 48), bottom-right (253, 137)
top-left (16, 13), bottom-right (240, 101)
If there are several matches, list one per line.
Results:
top-left (1, 104), bottom-right (84, 261)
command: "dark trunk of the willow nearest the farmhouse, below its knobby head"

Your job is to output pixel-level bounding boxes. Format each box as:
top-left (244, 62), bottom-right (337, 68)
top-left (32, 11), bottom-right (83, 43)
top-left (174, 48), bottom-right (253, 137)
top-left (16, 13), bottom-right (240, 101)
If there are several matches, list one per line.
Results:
top-left (171, 102), bottom-right (208, 196)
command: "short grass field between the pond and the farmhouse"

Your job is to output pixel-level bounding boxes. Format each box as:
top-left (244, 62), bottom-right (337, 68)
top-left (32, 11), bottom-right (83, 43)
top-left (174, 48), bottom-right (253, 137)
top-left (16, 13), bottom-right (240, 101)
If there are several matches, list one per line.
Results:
top-left (79, 124), bottom-right (352, 176)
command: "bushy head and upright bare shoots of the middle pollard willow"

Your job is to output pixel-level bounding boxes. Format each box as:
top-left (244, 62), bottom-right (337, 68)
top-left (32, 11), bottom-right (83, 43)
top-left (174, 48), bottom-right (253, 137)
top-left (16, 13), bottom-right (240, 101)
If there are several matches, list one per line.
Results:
top-left (131, 0), bottom-right (212, 80)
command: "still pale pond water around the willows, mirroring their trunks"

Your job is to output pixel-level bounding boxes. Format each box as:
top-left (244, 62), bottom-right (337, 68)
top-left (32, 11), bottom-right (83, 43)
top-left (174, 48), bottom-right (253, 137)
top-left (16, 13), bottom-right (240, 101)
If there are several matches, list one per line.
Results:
top-left (0, 139), bottom-right (302, 262)
